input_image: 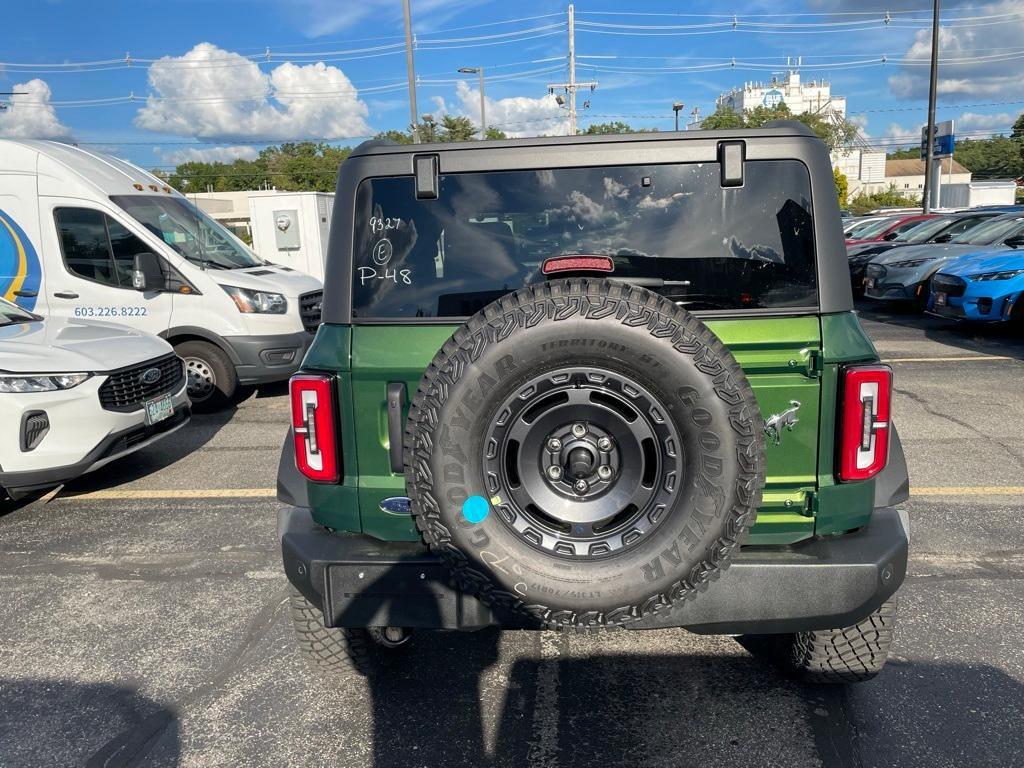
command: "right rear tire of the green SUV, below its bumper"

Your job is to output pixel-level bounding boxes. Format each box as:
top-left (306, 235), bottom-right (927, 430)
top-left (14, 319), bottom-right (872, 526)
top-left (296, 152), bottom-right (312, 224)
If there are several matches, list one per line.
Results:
top-left (737, 597), bottom-right (896, 684)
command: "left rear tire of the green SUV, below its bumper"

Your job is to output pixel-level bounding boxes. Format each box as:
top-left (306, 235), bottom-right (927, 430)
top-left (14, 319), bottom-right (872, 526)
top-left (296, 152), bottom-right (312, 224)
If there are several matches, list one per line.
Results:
top-left (289, 589), bottom-right (410, 677)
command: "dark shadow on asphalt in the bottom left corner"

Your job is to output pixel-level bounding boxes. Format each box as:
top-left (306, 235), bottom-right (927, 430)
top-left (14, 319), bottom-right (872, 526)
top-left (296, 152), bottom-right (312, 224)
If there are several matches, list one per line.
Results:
top-left (0, 678), bottom-right (179, 768)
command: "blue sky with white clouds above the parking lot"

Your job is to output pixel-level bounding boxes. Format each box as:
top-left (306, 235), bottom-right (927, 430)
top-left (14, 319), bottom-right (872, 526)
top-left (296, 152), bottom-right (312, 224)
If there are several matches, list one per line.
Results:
top-left (0, 0), bottom-right (1024, 169)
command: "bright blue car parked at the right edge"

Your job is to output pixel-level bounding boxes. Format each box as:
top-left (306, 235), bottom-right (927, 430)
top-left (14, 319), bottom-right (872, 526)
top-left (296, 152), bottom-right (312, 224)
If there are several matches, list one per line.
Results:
top-left (928, 251), bottom-right (1024, 323)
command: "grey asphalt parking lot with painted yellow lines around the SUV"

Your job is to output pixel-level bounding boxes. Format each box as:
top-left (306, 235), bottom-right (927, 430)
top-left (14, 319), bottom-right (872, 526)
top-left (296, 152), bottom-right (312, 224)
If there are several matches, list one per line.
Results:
top-left (0, 307), bottom-right (1024, 768)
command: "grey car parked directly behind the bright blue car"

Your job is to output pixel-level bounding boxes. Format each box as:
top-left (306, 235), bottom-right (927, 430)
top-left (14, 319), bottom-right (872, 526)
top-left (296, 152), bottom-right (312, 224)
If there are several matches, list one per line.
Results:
top-left (864, 213), bottom-right (1024, 309)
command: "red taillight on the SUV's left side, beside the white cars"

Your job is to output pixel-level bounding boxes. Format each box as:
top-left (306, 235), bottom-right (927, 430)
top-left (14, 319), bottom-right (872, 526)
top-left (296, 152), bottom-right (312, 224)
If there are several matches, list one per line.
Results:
top-left (290, 374), bottom-right (340, 482)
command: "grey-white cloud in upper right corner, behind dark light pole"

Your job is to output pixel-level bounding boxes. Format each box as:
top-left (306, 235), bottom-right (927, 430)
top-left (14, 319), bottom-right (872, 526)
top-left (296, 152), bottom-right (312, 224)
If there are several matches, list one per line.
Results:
top-left (889, 0), bottom-right (1024, 99)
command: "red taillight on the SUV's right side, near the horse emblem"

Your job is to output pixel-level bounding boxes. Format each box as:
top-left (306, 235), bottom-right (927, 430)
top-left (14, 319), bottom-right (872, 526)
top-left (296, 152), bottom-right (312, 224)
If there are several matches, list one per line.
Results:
top-left (839, 366), bottom-right (893, 481)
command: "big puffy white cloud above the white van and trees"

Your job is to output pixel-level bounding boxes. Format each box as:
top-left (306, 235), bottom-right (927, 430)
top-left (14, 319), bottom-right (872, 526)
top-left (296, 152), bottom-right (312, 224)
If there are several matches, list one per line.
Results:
top-left (135, 43), bottom-right (373, 141)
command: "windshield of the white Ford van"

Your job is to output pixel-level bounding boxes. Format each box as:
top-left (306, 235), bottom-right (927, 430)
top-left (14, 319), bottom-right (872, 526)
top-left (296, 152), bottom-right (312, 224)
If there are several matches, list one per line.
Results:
top-left (111, 195), bottom-right (263, 269)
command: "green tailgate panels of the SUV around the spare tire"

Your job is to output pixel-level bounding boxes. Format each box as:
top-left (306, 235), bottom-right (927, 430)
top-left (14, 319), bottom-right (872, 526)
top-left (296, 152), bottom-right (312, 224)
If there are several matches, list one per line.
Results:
top-left (346, 316), bottom-right (821, 544)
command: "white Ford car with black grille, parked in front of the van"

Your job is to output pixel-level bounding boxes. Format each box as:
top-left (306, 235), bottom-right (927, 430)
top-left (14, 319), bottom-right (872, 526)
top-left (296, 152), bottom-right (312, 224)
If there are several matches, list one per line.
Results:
top-left (0, 299), bottom-right (190, 499)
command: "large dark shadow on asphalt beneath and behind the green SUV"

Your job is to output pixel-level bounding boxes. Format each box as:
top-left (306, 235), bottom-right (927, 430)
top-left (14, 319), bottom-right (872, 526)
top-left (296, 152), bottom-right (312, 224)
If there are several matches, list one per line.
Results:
top-left (354, 633), bottom-right (1024, 768)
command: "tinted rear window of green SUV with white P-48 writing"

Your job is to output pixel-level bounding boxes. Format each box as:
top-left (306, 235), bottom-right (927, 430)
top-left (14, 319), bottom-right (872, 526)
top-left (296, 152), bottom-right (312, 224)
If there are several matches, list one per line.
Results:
top-left (352, 161), bottom-right (817, 319)
